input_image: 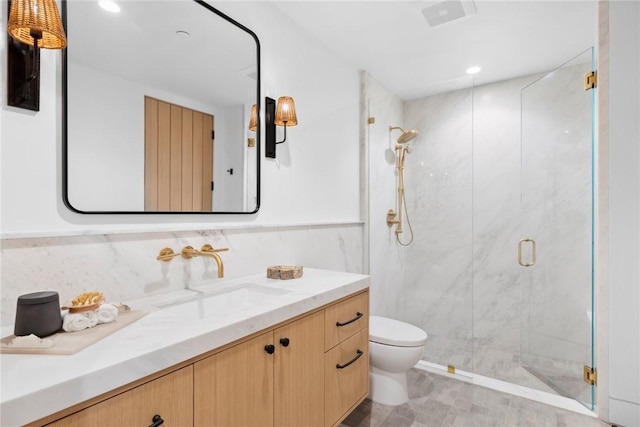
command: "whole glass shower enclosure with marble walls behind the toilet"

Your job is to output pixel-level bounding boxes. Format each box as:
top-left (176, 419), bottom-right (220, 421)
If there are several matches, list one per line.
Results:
top-left (363, 49), bottom-right (596, 409)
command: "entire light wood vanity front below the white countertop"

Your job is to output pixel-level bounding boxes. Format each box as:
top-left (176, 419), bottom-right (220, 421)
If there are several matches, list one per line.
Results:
top-left (30, 290), bottom-right (369, 427)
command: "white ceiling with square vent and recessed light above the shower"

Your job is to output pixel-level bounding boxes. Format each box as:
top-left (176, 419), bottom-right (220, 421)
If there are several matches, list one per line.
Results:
top-left (273, 0), bottom-right (597, 100)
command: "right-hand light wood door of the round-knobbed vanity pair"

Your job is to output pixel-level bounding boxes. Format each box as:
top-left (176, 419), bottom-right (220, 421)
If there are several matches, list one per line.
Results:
top-left (274, 311), bottom-right (324, 427)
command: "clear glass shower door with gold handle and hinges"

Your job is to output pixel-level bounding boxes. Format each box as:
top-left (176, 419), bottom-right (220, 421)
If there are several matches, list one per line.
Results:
top-left (518, 49), bottom-right (595, 409)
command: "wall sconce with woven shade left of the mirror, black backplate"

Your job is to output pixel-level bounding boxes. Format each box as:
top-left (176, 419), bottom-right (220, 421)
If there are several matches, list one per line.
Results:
top-left (7, 0), bottom-right (67, 111)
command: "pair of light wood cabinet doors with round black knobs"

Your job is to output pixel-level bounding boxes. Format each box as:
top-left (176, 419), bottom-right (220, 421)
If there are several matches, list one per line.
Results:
top-left (194, 311), bottom-right (324, 427)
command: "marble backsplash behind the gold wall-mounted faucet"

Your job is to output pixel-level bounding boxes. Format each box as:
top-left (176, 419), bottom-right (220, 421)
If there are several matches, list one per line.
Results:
top-left (0, 223), bottom-right (363, 325)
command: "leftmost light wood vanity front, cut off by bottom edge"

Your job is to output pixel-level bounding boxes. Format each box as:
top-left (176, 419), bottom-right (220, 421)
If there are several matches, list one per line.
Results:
top-left (48, 366), bottom-right (193, 427)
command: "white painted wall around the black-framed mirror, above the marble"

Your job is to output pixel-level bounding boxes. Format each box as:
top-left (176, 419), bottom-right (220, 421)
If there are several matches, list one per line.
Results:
top-left (0, 2), bottom-right (360, 236)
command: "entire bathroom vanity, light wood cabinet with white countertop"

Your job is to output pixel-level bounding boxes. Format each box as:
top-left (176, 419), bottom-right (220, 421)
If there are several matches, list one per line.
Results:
top-left (0, 269), bottom-right (370, 427)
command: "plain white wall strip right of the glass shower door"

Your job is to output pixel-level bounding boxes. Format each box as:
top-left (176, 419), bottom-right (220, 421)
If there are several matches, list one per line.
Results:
top-left (608, 1), bottom-right (640, 426)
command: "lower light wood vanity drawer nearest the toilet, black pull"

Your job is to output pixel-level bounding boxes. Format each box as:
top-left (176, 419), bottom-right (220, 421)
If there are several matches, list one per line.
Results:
top-left (324, 329), bottom-right (369, 426)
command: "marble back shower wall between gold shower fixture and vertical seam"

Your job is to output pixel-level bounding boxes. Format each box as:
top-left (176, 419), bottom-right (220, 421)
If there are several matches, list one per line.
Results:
top-left (398, 83), bottom-right (473, 372)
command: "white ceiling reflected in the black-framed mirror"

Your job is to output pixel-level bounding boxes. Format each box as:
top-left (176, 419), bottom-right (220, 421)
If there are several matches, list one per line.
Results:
top-left (65, 0), bottom-right (258, 109)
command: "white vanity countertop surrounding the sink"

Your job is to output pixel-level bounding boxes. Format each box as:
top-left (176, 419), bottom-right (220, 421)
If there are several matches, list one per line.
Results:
top-left (0, 268), bottom-right (370, 427)
